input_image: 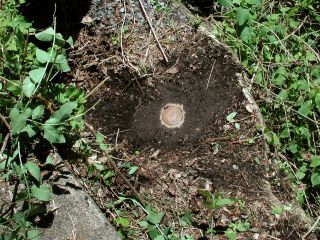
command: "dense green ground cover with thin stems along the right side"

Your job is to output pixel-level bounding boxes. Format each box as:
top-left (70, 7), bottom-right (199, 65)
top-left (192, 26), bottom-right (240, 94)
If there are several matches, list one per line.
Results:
top-left (212, 0), bottom-right (320, 212)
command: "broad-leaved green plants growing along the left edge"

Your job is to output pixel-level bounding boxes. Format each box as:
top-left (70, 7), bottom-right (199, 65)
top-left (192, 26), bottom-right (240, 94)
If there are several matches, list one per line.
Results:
top-left (0, 0), bottom-right (85, 239)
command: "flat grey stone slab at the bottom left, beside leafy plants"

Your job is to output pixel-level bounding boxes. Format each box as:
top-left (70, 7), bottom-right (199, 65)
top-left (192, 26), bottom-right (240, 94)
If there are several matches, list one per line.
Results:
top-left (40, 155), bottom-right (120, 240)
